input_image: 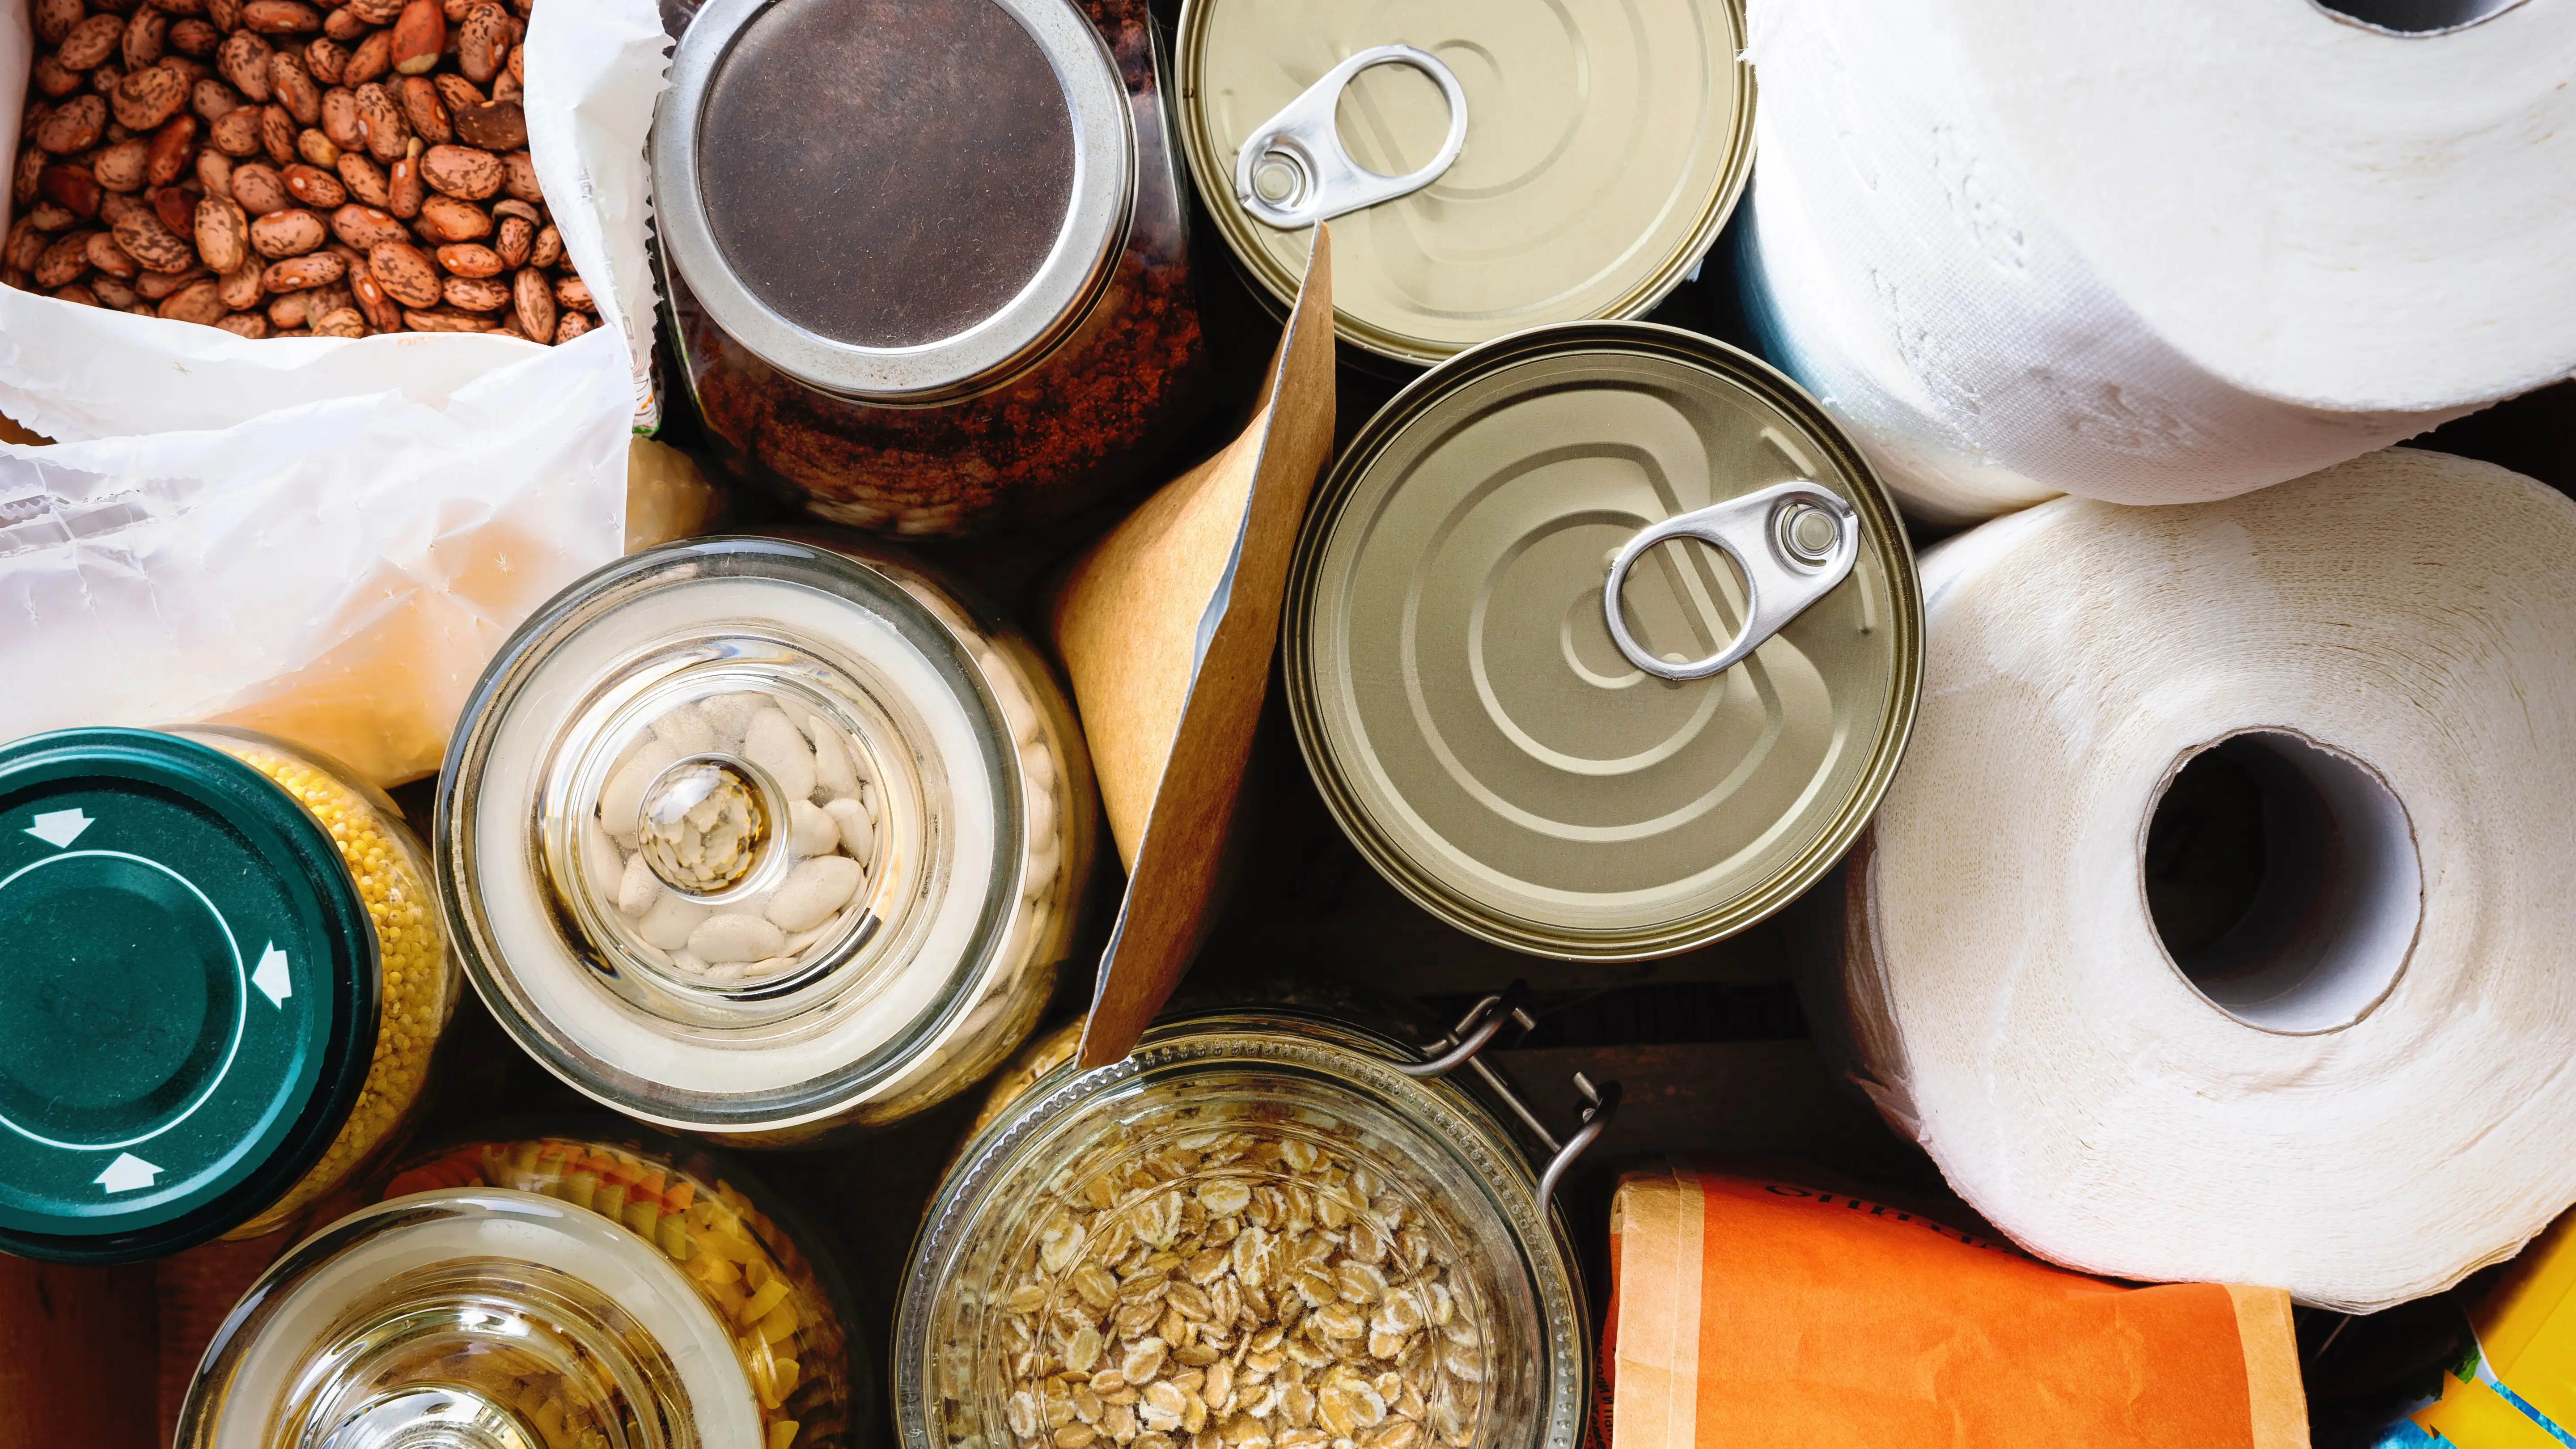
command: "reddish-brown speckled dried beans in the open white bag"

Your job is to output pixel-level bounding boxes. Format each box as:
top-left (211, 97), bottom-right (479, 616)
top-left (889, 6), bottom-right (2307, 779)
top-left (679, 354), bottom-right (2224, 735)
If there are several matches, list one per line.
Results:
top-left (0, 0), bottom-right (597, 343)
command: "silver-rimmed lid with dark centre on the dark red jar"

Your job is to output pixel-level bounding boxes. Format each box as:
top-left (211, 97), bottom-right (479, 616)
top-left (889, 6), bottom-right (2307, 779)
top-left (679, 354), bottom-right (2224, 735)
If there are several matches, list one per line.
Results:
top-left (652, 0), bottom-right (1136, 402)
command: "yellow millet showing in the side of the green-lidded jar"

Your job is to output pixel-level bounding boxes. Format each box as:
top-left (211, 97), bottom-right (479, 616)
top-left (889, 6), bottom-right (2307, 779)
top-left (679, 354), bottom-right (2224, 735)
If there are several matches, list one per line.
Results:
top-left (211, 740), bottom-right (456, 1237)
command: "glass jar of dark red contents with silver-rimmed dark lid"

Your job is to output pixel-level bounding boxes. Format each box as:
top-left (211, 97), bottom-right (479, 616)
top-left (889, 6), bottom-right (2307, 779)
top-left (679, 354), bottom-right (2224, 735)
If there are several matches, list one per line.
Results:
top-left (652, 0), bottom-right (1206, 534)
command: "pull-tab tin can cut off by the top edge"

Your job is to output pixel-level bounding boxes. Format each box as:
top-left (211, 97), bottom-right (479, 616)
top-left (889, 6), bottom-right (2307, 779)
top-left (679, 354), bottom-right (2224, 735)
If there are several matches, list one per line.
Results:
top-left (1180, 0), bottom-right (1754, 366)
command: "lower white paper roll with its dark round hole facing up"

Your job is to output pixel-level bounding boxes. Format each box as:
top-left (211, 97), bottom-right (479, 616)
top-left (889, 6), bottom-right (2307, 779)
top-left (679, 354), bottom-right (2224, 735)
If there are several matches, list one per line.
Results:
top-left (1821, 449), bottom-right (2576, 1312)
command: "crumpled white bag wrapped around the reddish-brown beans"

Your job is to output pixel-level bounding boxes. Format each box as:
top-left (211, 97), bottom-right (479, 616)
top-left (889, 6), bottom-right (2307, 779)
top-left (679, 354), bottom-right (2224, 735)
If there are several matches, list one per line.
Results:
top-left (0, 0), bottom-right (670, 784)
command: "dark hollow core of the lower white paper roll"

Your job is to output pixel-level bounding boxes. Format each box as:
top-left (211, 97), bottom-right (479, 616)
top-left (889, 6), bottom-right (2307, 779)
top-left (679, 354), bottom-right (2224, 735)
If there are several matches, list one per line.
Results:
top-left (2141, 730), bottom-right (2424, 1034)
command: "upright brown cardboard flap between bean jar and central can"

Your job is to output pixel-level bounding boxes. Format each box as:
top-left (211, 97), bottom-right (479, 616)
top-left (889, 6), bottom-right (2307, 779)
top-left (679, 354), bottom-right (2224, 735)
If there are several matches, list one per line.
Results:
top-left (1054, 227), bottom-right (1335, 1070)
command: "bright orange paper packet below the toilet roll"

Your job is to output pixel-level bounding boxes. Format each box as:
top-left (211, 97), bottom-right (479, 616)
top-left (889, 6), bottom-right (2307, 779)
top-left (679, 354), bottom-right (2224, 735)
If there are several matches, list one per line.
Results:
top-left (1602, 1168), bottom-right (2308, 1449)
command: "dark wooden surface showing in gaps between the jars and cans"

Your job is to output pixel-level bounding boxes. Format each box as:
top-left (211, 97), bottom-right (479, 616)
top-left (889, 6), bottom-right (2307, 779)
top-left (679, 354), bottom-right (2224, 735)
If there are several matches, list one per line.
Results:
top-left (0, 186), bottom-right (2576, 1449)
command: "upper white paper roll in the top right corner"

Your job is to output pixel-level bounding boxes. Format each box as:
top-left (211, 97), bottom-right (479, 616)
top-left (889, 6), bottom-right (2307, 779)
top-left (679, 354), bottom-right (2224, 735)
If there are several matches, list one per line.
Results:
top-left (1744, 0), bottom-right (2576, 521)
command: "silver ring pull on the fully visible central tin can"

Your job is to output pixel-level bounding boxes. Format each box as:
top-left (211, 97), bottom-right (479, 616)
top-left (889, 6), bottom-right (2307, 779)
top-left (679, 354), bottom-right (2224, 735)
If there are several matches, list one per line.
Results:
top-left (1602, 479), bottom-right (1860, 681)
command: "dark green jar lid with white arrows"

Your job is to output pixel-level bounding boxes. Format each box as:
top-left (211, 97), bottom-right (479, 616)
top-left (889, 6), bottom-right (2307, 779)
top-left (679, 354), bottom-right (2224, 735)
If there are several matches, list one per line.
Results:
top-left (0, 730), bottom-right (381, 1263)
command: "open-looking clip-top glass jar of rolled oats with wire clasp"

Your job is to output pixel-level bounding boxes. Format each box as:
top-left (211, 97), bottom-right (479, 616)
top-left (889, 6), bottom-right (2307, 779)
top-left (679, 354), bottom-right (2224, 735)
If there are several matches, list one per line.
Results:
top-left (894, 998), bottom-right (1615, 1449)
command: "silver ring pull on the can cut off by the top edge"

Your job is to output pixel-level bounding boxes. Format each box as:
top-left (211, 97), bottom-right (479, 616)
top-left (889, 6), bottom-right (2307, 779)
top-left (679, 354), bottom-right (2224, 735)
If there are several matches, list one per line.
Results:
top-left (1234, 47), bottom-right (1466, 232)
